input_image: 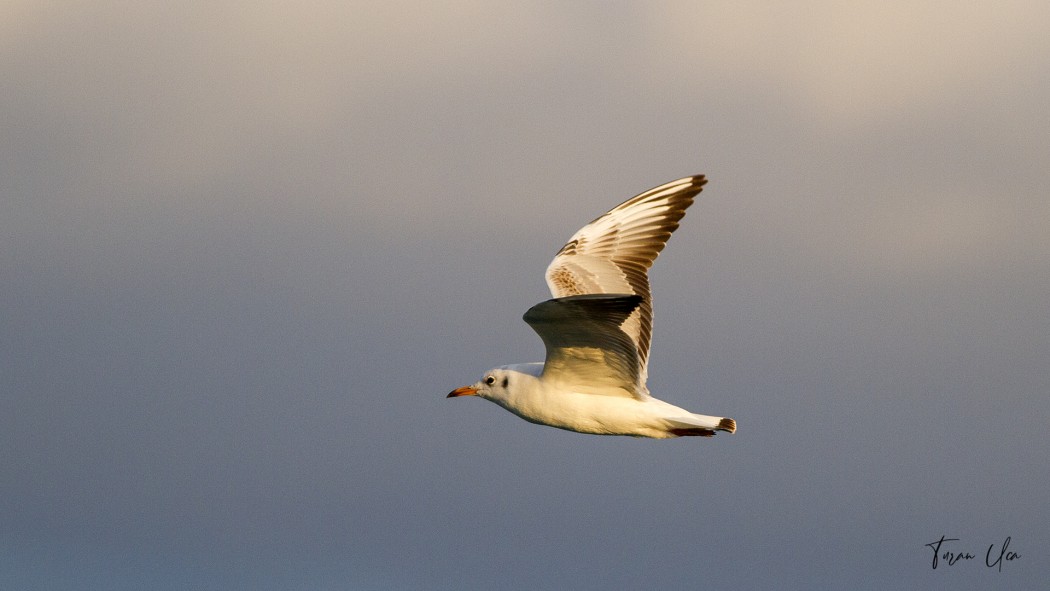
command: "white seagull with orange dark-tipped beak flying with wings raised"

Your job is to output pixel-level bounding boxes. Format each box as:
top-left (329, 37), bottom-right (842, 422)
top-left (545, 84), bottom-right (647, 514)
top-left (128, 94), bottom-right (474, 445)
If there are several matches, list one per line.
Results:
top-left (448, 174), bottom-right (736, 439)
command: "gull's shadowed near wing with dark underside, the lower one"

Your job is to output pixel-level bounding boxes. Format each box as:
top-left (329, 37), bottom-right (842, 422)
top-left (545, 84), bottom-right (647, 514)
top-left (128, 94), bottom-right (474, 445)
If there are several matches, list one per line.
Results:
top-left (523, 294), bottom-right (648, 398)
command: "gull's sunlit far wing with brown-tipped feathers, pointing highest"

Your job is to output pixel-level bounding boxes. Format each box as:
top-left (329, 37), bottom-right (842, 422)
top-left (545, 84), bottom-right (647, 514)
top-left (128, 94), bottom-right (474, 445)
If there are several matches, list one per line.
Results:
top-left (533, 174), bottom-right (708, 388)
